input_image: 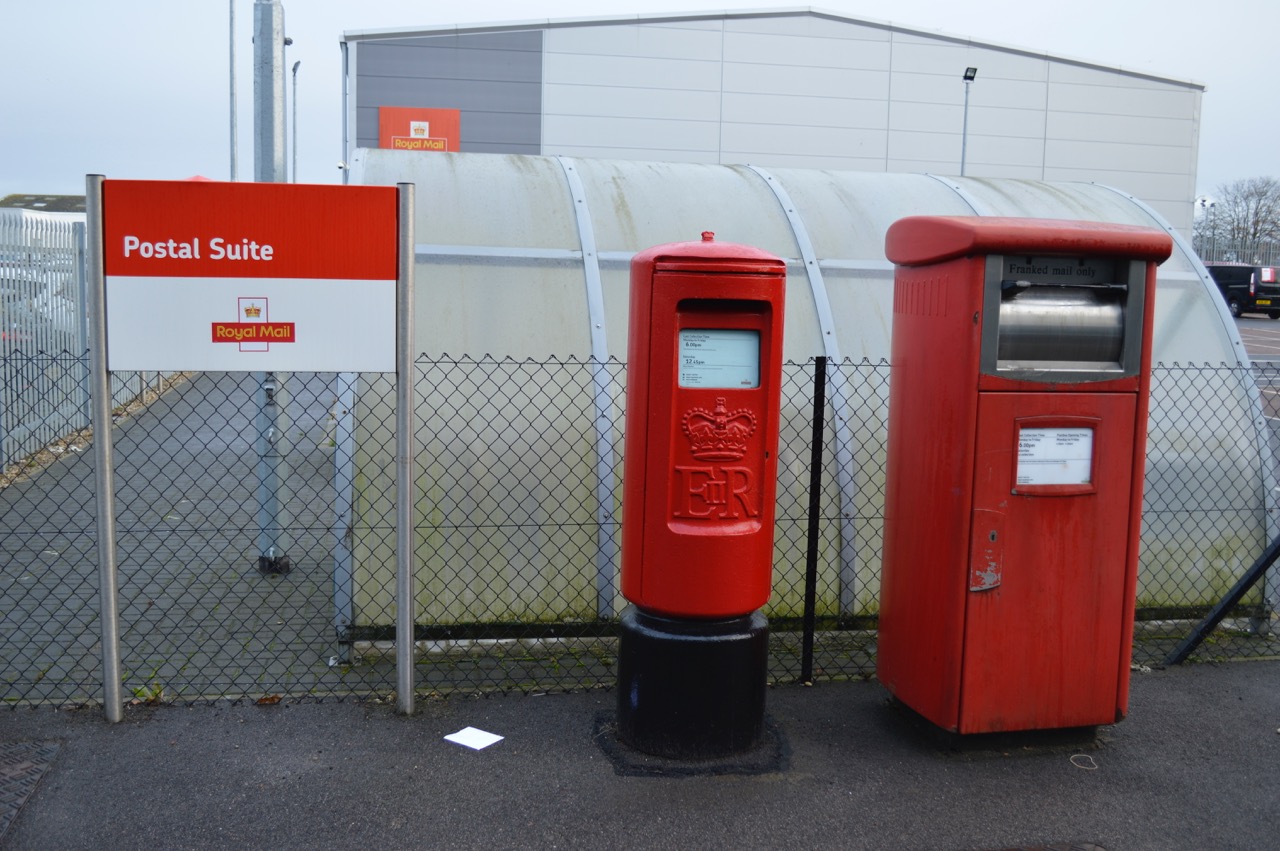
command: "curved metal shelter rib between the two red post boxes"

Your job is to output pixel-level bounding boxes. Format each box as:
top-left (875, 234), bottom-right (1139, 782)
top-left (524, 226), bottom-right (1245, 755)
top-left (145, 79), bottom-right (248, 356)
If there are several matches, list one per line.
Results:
top-left (746, 165), bottom-right (858, 614)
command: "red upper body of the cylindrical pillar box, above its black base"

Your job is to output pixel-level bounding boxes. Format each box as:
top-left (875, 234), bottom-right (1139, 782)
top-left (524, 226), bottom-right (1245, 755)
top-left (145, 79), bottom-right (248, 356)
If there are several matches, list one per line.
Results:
top-left (622, 234), bottom-right (786, 618)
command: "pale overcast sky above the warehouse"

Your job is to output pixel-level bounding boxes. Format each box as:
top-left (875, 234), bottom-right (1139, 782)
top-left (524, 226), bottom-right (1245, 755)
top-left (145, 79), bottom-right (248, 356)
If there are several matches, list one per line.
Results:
top-left (0, 0), bottom-right (1280, 204)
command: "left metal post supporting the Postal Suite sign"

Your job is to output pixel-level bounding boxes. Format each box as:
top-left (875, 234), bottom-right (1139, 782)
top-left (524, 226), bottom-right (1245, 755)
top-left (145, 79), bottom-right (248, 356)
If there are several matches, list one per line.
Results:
top-left (84, 174), bottom-right (124, 723)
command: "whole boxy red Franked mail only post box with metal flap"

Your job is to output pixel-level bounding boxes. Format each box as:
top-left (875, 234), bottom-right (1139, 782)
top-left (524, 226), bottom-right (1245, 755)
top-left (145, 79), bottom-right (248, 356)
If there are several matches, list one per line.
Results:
top-left (877, 216), bottom-right (1172, 733)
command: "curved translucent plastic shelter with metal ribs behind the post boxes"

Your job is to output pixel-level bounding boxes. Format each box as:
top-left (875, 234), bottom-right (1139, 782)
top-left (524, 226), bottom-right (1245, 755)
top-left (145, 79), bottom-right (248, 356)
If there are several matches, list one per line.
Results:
top-left (351, 150), bottom-right (1271, 622)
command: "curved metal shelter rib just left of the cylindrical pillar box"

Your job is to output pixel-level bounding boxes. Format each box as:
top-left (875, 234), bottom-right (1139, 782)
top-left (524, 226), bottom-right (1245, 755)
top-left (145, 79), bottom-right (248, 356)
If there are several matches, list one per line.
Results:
top-left (556, 156), bottom-right (618, 618)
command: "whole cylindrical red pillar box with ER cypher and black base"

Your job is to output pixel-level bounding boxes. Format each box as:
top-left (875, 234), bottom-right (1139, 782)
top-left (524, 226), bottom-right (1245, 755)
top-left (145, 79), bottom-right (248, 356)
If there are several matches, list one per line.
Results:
top-left (618, 233), bottom-right (786, 758)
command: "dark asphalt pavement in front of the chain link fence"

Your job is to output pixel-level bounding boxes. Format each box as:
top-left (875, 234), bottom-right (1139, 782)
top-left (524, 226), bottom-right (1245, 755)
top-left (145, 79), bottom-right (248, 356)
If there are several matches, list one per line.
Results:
top-left (0, 660), bottom-right (1280, 851)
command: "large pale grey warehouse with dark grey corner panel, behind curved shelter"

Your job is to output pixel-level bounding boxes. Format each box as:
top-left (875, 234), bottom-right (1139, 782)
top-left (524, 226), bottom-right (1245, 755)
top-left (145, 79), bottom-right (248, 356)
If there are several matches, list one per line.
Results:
top-left (343, 8), bottom-right (1204, 234)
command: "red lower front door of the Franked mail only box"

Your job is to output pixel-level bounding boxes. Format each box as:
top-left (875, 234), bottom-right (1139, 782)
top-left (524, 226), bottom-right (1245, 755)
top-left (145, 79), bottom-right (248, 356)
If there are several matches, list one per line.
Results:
top-left (959, 393), bottom-right (1140, 733)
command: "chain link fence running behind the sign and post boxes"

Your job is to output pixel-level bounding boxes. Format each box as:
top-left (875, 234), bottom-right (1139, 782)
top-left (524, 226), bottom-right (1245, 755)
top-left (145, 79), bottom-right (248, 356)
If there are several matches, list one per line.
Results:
top-left (0, 353), bottom-right (1280, 704)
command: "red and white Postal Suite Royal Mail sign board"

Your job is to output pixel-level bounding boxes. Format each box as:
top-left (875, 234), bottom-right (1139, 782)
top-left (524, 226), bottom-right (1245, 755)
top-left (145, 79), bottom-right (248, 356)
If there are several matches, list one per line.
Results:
top-left (102, 180), bottom-right (397, 372)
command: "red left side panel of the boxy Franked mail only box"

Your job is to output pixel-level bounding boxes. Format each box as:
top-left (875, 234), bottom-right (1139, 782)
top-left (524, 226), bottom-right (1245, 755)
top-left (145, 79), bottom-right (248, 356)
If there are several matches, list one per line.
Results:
top-left (876, 258), bottom-right (984, 729)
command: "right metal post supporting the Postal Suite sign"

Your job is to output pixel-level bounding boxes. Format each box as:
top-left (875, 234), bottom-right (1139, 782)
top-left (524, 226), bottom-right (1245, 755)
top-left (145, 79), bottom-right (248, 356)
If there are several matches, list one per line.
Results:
top-left (396, 183), bottom-right (417, 715)
